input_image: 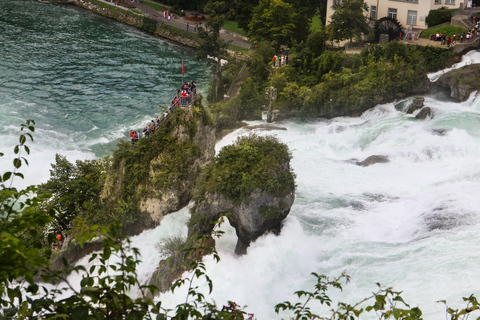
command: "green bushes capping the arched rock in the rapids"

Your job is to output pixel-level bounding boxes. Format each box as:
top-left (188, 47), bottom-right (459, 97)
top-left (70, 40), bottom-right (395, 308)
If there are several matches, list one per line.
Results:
top-left (196, 134), bottom-right (295, 203)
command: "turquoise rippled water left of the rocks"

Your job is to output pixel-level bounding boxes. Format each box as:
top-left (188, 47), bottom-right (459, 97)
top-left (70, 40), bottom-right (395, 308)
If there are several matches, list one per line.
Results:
top-left (0, 0), bottom-right (210, 183)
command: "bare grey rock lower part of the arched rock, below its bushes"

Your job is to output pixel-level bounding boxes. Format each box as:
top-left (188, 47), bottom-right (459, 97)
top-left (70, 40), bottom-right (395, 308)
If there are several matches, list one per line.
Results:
top-left (190, 189), bottom-right (295, 255)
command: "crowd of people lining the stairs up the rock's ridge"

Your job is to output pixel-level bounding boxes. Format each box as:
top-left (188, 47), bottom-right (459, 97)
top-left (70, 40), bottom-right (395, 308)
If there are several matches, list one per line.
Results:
top-left (129, 80), bottom-right (197, 146)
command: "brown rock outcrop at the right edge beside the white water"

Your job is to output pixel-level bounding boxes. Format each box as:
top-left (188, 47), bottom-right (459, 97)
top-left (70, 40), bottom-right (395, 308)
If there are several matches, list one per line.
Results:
top-left (435, 64), bottom-right (480, 101)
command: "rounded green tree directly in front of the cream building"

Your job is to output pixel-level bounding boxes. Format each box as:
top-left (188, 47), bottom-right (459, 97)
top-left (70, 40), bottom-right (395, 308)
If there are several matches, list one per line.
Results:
top-left (326, 0), bottom-right (370, 43)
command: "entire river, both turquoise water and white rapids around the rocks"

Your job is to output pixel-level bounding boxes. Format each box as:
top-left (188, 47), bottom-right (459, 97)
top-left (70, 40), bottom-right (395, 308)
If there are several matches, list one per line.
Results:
top-left (0, 0), bottom-right (480, 320)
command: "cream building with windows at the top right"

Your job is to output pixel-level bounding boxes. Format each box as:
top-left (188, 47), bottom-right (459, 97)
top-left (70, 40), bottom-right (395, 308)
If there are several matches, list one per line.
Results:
top-left (327, 0), bottom-right (480, 29)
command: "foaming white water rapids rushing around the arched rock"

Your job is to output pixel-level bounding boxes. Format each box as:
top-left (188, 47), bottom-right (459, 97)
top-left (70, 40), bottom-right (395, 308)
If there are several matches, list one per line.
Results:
top-left (47, 89), bottom-right (480, 320)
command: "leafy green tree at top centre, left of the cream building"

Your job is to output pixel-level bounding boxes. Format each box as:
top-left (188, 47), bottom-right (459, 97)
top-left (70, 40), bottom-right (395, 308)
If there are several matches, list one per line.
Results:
top-left (248, 0), bottom-right (297, 52)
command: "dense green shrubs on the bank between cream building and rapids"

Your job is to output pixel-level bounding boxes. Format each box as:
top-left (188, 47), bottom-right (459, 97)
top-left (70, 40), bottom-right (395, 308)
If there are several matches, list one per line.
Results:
top-left (278, 41), bottom-right (452, 117)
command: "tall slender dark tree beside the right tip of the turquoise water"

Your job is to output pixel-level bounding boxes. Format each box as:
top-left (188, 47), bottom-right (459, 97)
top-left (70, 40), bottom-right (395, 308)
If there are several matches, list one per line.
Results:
top-left (197, 1), bottom-right (227, 101)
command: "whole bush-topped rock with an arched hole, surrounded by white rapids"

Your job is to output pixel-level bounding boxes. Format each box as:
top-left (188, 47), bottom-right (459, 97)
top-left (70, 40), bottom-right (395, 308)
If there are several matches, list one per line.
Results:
top-left (150, 135), bottom-right (295, 291)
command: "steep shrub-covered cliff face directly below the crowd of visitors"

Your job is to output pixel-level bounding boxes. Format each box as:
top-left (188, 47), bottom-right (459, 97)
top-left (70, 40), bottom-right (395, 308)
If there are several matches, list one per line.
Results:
top-left (101, 102), bottom-right (215, 233)
